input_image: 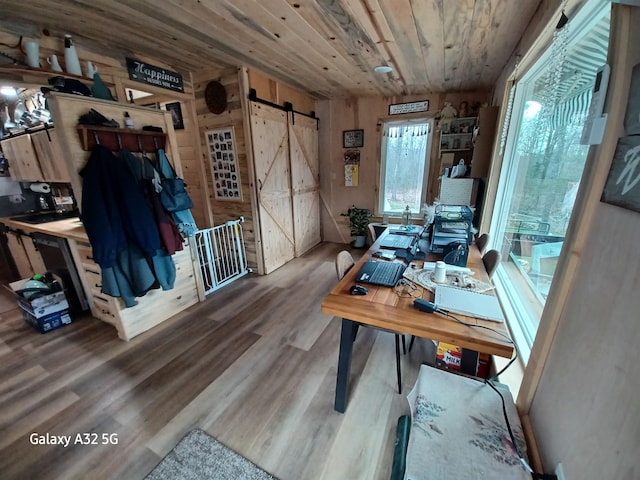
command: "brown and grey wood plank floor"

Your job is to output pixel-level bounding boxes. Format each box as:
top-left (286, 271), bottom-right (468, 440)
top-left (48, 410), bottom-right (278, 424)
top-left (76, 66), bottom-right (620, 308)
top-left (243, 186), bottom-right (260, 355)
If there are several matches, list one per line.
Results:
top-left (0, 243), bottom-right (432, 480)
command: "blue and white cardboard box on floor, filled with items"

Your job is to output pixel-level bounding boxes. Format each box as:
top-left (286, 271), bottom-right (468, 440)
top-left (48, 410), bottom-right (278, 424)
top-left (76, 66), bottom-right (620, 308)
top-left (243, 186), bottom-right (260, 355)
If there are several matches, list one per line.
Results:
top-left (9, 278), bottom-right (71, 333)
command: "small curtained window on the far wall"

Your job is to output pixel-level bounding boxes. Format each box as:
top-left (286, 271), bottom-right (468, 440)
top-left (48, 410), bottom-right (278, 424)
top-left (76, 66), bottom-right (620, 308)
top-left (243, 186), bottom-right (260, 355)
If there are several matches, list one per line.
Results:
top-left (378, 119), bottom-right (433, 215)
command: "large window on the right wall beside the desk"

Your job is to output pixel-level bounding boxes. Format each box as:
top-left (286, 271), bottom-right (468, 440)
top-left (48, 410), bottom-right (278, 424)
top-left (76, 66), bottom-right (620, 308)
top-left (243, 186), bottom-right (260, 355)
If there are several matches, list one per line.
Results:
top-left (490, 0), bottom-right (609, 358)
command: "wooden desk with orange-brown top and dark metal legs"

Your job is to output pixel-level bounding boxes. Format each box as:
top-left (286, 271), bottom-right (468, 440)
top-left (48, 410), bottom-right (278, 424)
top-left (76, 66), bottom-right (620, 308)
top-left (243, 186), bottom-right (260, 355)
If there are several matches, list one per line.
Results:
top-left (322, 230), bottom-right (513, 413)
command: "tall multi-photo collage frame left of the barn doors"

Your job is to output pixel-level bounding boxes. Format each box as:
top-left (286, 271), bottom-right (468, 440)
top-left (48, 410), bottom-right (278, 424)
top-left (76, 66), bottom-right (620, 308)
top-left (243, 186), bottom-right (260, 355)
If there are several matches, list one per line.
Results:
top-left (205, 127), bottom-right (242, 201)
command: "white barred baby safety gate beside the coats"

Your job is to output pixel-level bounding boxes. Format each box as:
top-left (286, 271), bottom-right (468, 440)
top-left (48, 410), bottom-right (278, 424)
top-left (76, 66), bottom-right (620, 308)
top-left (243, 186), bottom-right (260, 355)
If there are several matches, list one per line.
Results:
top-left (195, 217), bottom-right (251, 295)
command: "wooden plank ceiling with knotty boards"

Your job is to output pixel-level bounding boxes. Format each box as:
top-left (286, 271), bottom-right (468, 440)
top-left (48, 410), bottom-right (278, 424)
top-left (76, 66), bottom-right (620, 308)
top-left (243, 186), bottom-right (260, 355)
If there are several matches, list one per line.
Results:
top-left (0, 0), bottom-right (540, 98)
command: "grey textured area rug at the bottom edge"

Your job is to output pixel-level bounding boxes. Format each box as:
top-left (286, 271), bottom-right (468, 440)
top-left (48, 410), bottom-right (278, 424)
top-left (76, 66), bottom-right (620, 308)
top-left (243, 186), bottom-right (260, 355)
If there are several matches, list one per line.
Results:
top-left (145, 429), bottom-right (277, 480)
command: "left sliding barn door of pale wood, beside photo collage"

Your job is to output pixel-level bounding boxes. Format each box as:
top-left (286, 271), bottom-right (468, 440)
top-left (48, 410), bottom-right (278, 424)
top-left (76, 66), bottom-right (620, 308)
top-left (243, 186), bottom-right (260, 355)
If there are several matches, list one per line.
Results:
top-left (251, 103), bottom-right (295, 273)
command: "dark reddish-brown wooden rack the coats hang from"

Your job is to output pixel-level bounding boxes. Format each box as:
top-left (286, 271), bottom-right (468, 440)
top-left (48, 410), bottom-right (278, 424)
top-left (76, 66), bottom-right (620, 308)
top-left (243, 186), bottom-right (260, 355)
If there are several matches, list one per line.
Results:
top-left (78, 125), bottom-right (167, 152)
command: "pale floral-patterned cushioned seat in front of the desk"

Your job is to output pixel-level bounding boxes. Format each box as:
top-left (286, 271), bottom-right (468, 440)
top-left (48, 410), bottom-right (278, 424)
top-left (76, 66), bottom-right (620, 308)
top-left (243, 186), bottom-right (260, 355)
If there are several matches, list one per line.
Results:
top-left (405, 365), bottom-right (531, 480)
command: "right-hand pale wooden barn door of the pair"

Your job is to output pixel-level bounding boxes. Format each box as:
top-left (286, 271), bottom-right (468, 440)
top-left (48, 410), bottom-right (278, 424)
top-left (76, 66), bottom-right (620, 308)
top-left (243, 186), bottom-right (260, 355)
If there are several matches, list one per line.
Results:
top-left (289, 112), bottom-right (320, 257)
